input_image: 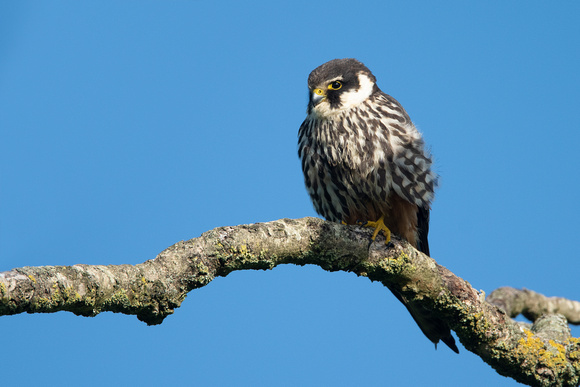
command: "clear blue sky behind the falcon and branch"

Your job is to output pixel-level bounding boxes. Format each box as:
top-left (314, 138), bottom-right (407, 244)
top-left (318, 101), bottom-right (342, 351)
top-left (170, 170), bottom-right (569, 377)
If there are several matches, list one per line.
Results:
top-left (0, 1), bottom-right (580, 386)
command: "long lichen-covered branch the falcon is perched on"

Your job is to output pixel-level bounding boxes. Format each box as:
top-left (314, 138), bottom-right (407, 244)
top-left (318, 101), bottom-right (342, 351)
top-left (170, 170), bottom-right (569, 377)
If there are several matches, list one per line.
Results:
top-left (0, 218), bottom-right (580, 386)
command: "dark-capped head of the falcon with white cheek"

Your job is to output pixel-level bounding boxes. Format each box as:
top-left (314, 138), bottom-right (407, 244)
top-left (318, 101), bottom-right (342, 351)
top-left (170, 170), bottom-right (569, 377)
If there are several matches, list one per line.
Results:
top-left (308, 58), bottom-right (379, 117)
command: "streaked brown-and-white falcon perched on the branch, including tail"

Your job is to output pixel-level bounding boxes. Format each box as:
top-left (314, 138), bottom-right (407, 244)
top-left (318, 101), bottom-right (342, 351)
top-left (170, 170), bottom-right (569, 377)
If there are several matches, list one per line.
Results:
top-left (298, 58), bottom-right (459, 353)
